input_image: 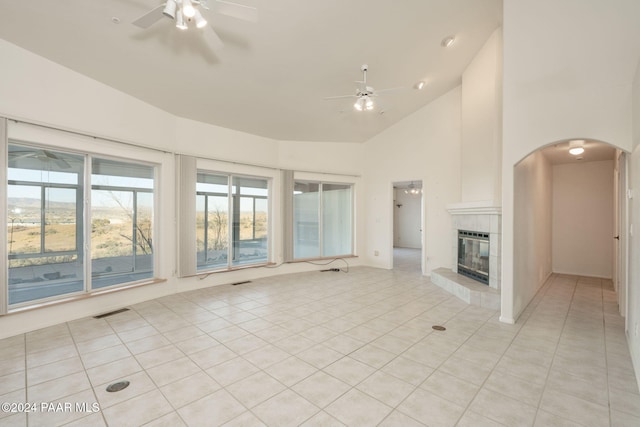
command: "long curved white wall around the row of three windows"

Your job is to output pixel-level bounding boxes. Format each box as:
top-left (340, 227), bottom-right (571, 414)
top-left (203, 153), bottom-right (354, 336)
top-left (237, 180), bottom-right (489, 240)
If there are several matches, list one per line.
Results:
top-left (0, 40), bottom-right (365, 338)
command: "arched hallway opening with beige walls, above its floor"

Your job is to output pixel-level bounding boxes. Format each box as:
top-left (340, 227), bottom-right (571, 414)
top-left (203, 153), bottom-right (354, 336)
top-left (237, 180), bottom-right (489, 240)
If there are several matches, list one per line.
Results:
top-left (513, 139), bottom-right (627, 322)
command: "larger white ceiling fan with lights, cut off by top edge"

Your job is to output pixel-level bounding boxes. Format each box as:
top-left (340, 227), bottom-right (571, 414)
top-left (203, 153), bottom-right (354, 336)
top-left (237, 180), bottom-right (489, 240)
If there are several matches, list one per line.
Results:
top-left (133, 0), bottom-right (258, 49)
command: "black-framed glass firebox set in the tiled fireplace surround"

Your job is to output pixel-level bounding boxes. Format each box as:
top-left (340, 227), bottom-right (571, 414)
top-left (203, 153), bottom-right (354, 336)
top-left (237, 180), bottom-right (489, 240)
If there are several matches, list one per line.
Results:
top-left (458, 230), bottom-right (490, 285)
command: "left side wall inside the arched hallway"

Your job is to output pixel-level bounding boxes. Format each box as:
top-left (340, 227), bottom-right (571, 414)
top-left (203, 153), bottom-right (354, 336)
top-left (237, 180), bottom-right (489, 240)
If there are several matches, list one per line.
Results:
top-left (503, 151), bottom-right (552, 320)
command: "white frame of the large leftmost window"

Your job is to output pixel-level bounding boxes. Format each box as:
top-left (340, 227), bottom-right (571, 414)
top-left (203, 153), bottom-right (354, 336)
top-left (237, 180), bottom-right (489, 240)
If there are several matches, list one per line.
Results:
top-left (0, 120), bottom-right (172, 315)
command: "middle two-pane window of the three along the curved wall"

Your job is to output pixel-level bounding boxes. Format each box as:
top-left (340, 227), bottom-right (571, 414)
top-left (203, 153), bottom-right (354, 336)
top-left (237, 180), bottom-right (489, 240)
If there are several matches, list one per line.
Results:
top-left (196, 172), bottom-right (269, 270)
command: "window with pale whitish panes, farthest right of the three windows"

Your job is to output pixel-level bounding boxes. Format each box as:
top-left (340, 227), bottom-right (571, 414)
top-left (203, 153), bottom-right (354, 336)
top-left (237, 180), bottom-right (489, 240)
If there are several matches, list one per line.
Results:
top-left (293, 181), bottom-right (353, 259)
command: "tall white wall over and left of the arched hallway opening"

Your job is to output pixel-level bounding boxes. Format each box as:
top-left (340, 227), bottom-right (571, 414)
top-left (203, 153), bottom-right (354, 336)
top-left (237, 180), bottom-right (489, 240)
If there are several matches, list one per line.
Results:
top-left (501, 0), bottom-right (640, 322)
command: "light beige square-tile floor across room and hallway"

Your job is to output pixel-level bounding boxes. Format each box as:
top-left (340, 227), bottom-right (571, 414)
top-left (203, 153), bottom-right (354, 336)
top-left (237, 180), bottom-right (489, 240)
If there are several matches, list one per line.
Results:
top-left (0, 267), bottom-right (640, 427)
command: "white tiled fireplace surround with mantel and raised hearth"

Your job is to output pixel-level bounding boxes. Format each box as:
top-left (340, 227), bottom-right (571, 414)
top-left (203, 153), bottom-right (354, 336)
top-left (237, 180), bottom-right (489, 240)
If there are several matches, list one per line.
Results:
top-left (431, 202), bottom-right (502, 309)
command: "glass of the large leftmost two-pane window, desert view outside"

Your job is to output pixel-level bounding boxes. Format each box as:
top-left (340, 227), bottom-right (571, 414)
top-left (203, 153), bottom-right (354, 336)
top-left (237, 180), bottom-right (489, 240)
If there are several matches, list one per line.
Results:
top-left (7, 141), bottom-right (155, 306)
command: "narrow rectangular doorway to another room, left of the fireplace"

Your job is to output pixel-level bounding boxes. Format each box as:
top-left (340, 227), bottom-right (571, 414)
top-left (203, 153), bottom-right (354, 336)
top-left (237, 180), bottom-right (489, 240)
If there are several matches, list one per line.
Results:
top-left (393, 180), bottom-right (423, 273)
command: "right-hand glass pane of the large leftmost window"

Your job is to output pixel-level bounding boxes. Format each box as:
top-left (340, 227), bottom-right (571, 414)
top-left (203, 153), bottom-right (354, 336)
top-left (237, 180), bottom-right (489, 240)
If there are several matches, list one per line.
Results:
top-left (91, 158), bottom-right (154, 289)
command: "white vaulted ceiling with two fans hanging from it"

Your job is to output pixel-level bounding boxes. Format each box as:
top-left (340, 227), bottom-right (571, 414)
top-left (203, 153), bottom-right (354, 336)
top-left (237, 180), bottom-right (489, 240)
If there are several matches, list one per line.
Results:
top-left (0, 0), bottom-right (502, 142)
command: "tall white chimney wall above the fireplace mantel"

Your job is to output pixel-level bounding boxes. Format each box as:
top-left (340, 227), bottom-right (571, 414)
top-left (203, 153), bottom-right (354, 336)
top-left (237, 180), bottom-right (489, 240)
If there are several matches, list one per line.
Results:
top-left (461, 28), bottom-right (502, 206)
